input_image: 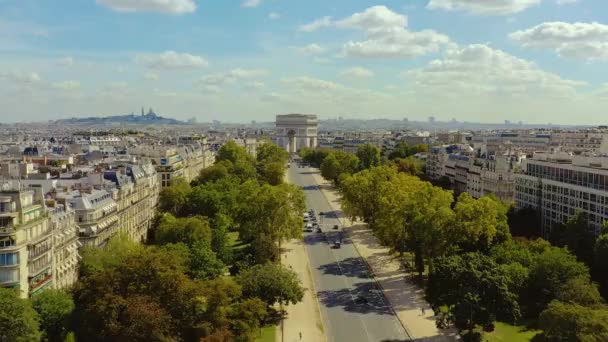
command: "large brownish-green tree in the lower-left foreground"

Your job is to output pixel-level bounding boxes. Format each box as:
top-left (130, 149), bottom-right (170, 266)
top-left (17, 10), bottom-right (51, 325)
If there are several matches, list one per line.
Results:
top-left (73, 246), bottom-right (214, 341)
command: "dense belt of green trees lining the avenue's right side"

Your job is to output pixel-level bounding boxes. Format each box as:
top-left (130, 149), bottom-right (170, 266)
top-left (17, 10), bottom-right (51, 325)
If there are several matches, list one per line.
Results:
top-left (339, 165), bottom-right (608, 340)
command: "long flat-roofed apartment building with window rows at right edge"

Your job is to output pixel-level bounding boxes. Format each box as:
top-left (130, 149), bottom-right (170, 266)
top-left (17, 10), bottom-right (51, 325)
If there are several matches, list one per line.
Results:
top-left (515, 152), bottom-right (608, 235)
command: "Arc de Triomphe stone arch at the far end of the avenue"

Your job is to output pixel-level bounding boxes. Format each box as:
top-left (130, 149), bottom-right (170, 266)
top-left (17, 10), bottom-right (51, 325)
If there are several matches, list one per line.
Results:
top-left (276, 114), bottom-right (317, 153)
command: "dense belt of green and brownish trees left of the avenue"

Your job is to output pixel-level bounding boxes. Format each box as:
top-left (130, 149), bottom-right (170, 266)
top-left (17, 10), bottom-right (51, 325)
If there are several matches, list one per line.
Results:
top-left (0, 142), bottom-right (304, 341)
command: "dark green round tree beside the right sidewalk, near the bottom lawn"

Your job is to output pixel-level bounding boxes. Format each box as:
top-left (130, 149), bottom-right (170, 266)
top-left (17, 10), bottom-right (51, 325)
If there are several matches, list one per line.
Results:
top-left (426, 253), bottom-right (520, 329)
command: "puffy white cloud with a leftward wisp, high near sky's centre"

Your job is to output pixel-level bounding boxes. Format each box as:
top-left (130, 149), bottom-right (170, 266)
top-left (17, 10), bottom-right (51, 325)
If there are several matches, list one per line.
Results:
top-left (300, 6), bottom-right (450, 59)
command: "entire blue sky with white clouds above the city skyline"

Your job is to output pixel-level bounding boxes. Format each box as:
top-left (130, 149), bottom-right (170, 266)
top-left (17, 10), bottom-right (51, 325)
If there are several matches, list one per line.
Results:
top-left (0, 0), bottom-right (608, 124)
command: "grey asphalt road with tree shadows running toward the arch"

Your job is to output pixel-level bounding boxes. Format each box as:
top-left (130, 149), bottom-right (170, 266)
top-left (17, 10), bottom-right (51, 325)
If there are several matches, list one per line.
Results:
top-left (288, 163), bottom-right (408, 342)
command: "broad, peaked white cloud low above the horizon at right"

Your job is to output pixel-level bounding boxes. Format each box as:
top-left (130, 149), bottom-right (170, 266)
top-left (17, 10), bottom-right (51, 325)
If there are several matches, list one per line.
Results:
top-left (403, 44), bottom-right (585, 100)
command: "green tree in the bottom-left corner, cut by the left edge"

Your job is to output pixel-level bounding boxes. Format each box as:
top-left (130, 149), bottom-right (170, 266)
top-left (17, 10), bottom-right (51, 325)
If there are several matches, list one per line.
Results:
top-left (0, 287), bottom-right (41, 342)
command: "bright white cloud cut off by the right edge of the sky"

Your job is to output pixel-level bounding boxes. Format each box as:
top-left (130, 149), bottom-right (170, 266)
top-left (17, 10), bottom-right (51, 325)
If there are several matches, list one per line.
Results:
top-left (509, 22), bottom-right (608, 60)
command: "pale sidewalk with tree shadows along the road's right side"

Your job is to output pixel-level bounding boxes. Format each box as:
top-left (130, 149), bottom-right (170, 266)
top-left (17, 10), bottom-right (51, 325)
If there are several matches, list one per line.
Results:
top-left (313, 174), bottom-right (457, 341)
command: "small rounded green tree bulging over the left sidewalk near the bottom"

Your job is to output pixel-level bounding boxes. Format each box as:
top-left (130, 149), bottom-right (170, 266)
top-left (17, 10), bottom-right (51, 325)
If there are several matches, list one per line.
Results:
top-left (236, 262), bottom-right (304, 307)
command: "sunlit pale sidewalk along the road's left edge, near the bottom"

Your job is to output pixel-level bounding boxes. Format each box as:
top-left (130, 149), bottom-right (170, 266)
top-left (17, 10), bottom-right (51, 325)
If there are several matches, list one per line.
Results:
top-left (276, 240), bottom-right (327, 342)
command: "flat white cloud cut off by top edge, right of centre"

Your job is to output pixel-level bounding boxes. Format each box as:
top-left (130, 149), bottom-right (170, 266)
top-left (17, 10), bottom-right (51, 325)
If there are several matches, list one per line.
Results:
top-left (426, 0), bottom-right (542, 15)
